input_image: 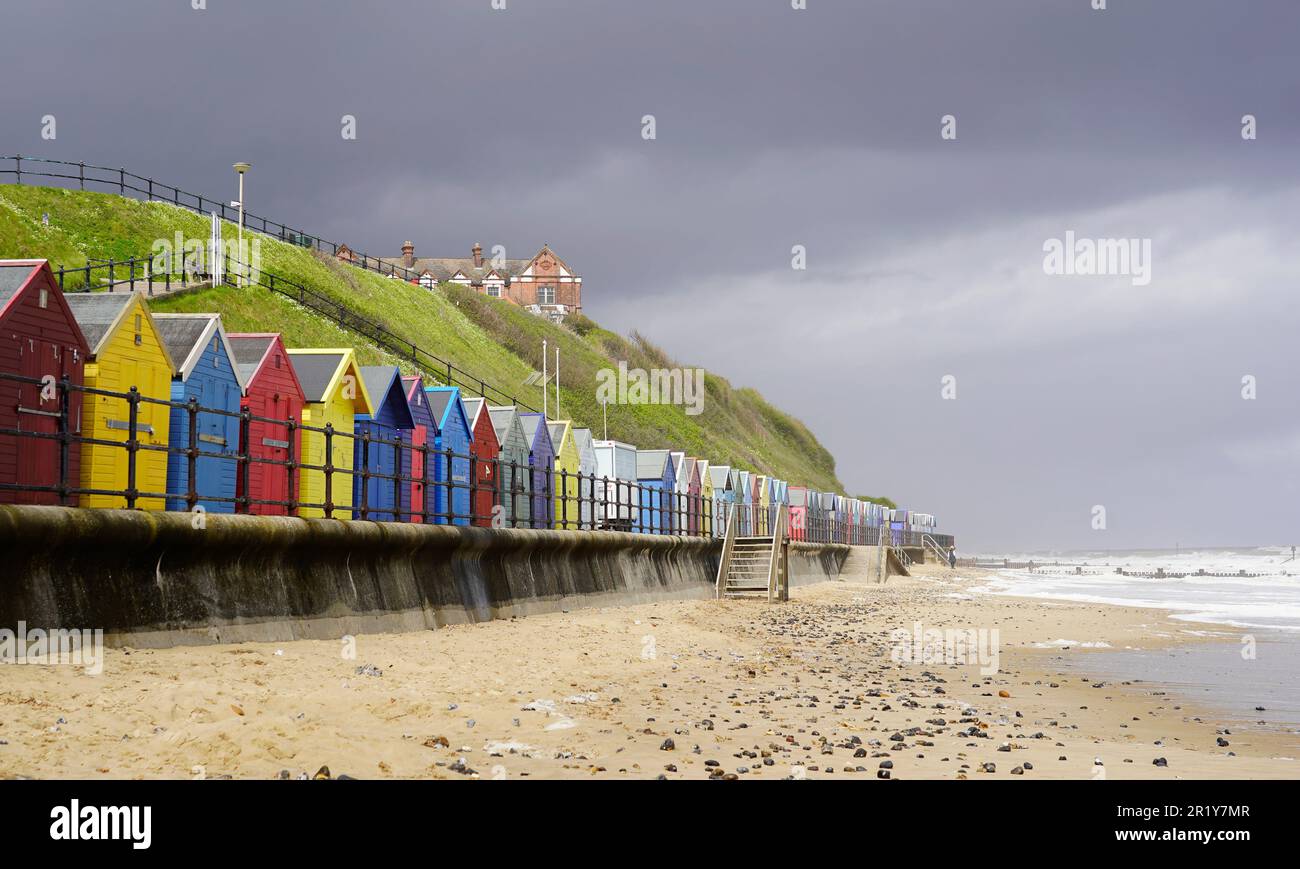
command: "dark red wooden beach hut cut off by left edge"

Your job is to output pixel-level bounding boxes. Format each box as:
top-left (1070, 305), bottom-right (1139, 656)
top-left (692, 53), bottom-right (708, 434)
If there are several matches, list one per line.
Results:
top-left (0, 259), bottom-right (90, 503)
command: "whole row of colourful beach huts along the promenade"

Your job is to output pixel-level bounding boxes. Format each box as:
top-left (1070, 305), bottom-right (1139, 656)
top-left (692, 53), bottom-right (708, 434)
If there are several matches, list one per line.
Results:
top-left (0, 260), bottom-right (936, 542)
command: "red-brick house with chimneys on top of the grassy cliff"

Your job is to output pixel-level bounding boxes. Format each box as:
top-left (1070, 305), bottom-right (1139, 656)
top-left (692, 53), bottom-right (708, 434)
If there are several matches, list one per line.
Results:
top-left (384, 242), bottom-right (582, 320)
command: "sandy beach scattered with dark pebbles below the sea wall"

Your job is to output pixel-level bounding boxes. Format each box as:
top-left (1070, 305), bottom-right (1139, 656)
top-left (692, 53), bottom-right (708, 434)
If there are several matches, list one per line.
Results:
top-left (0, 567), bottom-right (1300, 781)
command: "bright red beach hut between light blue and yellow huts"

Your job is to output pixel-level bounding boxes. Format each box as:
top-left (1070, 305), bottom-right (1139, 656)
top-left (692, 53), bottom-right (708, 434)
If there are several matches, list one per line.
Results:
top-left (226, 332), bottom-right (307, 516)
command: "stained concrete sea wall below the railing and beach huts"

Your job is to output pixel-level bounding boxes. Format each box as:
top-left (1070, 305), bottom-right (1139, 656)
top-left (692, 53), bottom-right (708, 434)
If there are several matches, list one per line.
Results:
top-left (0, 505), bottom-right (848, 647)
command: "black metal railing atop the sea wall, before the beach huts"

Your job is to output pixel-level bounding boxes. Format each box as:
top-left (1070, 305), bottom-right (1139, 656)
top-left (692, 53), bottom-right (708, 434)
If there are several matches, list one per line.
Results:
top-left (0, 372), bottom-right (956, 544)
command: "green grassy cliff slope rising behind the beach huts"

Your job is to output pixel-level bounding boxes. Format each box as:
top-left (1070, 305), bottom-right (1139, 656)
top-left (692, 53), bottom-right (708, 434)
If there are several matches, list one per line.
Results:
top-left (0, 185), bottom-right (842, 492)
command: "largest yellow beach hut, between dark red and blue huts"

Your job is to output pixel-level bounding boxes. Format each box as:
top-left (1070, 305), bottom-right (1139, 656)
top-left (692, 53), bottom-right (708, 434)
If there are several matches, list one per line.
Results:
top-left (64, 293), bottom-right (176, 510)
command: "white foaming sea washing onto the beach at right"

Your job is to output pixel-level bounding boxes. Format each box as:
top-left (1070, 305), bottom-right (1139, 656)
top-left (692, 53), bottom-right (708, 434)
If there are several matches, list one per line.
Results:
top-left (967, 546), bottom-right (1300, 734)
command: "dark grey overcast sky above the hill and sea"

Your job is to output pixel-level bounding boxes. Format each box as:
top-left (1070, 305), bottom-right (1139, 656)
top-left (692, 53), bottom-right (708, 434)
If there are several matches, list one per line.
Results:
top-left (0, 0), bottom-right (1300, 552)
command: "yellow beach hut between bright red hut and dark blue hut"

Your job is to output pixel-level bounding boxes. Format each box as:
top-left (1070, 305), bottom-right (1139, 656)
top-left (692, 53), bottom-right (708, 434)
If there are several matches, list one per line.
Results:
top-left (289, 347), bottom-right (374, 519)
